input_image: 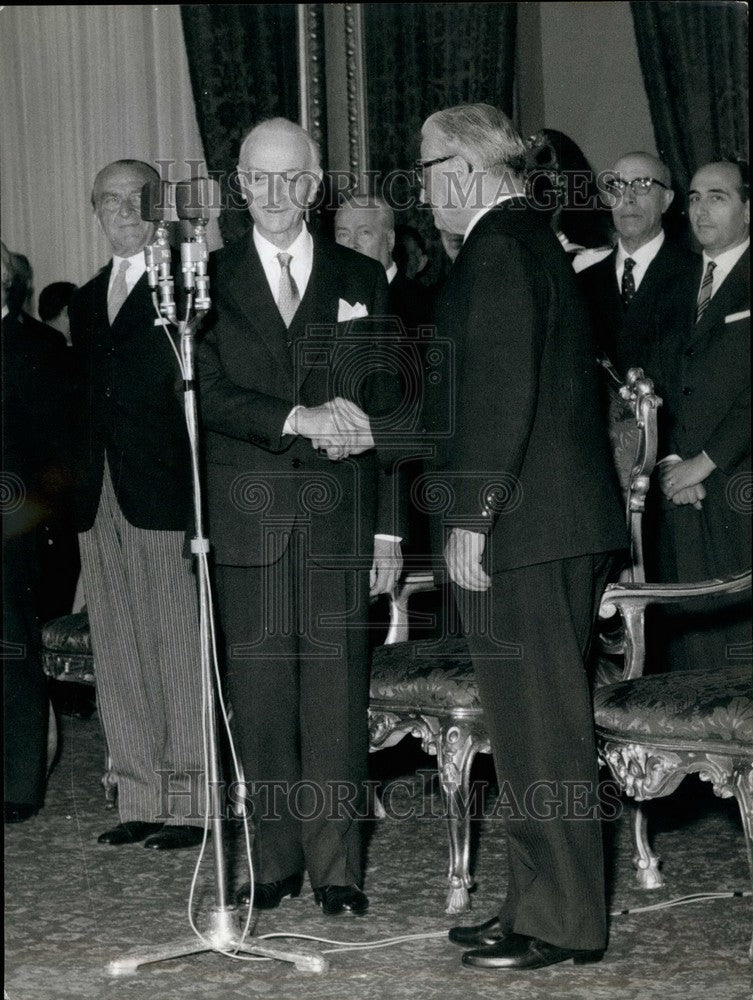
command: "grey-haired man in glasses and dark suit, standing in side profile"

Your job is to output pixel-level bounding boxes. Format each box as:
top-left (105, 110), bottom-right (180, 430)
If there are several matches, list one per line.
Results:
top-left (418, 105), bottom-right (625, 969)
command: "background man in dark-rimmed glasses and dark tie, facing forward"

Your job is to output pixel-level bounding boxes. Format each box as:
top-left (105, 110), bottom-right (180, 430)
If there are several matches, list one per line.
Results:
top-left (578, 152), bottom-right (697, 375)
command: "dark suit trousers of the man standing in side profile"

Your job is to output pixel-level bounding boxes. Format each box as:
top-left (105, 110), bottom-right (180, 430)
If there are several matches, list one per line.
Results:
top-left (454, 555), bottom-right (610, 949)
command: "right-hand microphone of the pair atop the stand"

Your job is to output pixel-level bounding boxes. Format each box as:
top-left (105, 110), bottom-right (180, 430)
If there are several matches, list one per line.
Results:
top-left (175, 177), bottom-right (220, 313)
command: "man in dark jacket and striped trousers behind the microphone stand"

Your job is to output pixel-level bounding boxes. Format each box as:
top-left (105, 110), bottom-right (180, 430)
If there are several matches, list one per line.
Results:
top-left (69, 160), bottom-right (202, 850)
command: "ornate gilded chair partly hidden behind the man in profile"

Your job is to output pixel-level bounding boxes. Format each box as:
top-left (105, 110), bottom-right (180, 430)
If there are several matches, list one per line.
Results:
top-left (370, 372), bottom-right (661, 913)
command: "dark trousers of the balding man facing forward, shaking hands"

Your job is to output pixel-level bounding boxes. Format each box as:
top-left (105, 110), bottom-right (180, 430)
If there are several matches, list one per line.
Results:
top-left (217, 532), bottom-right (369, 888)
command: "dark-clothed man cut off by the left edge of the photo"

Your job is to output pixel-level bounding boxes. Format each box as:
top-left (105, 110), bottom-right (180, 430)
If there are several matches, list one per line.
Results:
top-left (0, 244), bottom-right (73, 823)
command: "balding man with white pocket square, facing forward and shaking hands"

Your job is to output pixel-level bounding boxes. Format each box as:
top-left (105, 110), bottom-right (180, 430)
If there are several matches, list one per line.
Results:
top-left (198, 118), bottom-right (401, 914)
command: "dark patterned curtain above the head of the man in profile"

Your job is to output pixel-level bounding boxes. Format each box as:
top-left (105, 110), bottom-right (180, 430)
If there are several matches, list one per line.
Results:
top-left (363, 3), bottom-right (517, 278)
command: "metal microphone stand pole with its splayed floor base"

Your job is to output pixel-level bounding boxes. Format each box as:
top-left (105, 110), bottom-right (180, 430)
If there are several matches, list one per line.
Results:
top-left (108, 296), bottom-right (327, 976)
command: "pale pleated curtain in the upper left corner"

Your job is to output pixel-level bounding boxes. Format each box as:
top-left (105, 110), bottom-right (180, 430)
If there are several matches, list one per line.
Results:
top-left (0, 4), bottom-right (212, 304)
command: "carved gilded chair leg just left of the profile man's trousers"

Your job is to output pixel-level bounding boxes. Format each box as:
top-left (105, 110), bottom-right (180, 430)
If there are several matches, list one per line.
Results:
top-left (437, 723), bottom-right (477, 913)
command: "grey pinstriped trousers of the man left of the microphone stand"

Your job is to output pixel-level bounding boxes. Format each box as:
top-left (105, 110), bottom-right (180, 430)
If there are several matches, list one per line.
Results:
top-left (79, 461), bottom-right (203, 824)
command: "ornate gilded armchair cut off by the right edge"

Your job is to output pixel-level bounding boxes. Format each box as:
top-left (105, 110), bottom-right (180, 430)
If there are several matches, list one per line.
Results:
top-left (594, 571), bottom-right (753, 961)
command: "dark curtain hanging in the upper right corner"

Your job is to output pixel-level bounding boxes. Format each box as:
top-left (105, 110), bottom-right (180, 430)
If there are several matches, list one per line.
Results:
top-left (630, 0), bottom-right (748, 190)
